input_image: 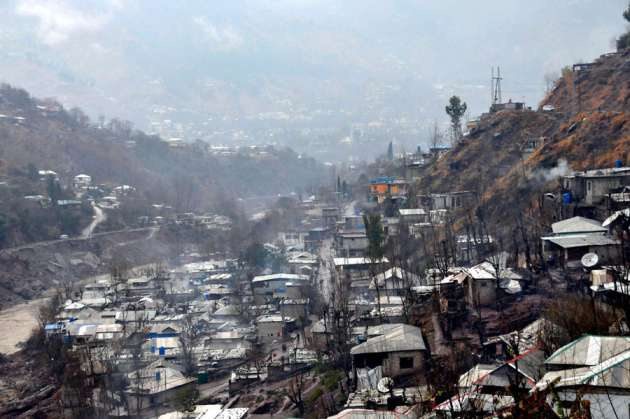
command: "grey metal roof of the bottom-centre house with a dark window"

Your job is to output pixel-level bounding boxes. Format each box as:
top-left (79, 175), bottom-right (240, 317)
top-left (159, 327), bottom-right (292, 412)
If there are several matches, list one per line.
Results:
top-left (350, 324), bottom-right (426, 355)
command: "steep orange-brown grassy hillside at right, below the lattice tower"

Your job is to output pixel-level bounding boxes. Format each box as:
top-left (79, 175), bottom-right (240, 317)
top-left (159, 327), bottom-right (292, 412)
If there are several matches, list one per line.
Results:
top-left (419, 52), bottom-right (630, 231)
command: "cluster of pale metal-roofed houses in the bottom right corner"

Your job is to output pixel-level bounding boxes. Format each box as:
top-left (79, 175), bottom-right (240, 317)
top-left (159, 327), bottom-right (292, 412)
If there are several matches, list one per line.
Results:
top-left (434, 320), bottom-right (630, 418)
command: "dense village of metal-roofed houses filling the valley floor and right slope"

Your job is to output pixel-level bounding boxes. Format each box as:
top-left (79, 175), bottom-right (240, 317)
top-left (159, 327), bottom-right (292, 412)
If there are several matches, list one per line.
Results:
top-left (4, 140), bottom-right (630, 418)
